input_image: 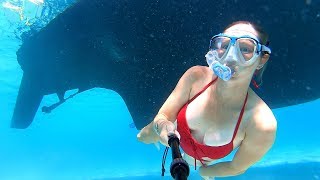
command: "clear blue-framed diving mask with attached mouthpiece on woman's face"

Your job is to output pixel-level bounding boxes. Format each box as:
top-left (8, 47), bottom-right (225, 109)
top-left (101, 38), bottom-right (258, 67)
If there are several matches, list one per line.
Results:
top-left (205, 34), bottom-right (271, 81)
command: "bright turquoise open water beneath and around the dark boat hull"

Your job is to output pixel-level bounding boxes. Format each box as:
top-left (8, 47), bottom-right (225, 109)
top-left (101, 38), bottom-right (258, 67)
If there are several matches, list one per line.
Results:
top-left (0, 0), bottom-right (320, 180)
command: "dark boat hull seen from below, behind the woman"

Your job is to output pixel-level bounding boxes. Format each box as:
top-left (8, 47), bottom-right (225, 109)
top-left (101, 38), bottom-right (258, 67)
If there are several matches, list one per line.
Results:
top-left (11, 0), bottom-right (320, 129)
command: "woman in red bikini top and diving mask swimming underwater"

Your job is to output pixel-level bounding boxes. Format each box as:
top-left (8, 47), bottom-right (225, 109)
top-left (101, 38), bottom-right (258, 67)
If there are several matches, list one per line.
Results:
top-left (137, 21), bottom-right (277, 179)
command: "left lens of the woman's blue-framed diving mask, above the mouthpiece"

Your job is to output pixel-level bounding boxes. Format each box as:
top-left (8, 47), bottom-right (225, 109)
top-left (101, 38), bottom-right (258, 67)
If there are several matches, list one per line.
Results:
top-left (210, 37), bottom-right (230, 58)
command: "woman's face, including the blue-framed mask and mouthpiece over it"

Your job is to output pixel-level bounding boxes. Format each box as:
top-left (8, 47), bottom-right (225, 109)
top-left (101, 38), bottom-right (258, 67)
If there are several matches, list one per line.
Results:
top-left (205, 24), bottom-right (268, 81)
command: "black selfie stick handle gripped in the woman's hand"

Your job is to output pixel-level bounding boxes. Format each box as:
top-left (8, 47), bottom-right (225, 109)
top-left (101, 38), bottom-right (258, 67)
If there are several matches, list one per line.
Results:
top-left (168, 134), bottom-right (190, 180)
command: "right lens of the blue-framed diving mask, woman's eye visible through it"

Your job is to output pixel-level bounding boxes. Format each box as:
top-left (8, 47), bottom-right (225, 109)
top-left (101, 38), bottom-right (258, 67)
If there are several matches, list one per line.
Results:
top-left (237, 38), bottom-right (257, 61)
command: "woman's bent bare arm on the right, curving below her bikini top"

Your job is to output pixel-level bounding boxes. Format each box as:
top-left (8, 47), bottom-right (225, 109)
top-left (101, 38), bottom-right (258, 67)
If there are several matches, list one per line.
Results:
top-left (200, 110), bottom-right (277, 177)
